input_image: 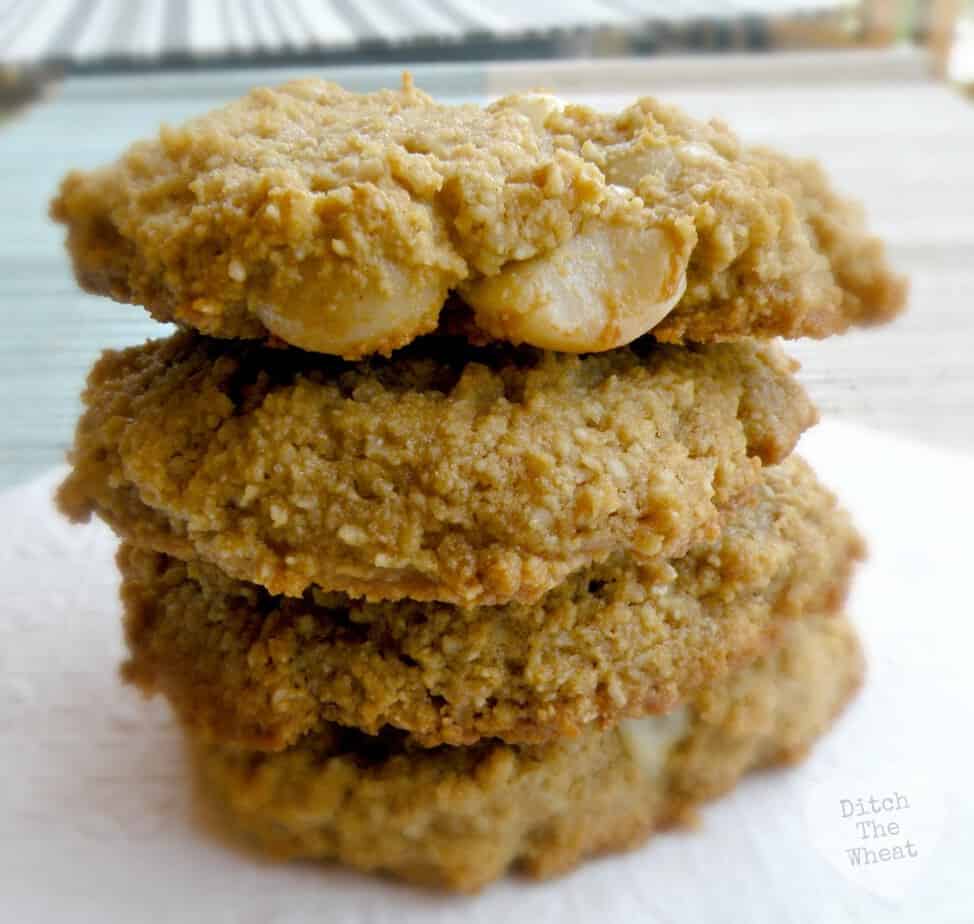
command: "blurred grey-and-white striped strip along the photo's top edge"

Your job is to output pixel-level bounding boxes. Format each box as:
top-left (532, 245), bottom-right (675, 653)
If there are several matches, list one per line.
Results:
top-left (0, 0), bottom-right (971, 86)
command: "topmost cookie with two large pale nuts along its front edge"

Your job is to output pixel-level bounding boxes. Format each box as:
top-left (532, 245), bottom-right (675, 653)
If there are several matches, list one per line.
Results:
top-left (52, 76), bottom-right (905, 359)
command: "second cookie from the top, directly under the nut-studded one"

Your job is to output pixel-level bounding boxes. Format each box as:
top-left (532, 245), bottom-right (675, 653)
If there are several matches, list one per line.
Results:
top-left (59, 333), bottom-right (815, 605)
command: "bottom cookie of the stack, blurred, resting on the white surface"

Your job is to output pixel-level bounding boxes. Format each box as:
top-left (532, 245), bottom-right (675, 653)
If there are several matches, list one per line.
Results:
top-left (194, 616), bottom-right (862, 891)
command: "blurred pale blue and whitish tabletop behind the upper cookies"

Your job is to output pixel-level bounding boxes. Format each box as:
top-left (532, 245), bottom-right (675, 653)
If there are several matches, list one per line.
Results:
top-left (0, 52), bottom-right (974, 486)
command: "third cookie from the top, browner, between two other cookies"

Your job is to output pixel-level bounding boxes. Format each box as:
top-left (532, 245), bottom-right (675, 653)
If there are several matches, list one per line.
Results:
top-left (119, 457), bottom-right (862, 750)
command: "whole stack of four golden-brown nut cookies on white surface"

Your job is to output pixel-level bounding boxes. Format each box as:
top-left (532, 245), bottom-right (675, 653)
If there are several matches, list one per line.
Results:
top-left (53, 79), bottom-right (904, 889)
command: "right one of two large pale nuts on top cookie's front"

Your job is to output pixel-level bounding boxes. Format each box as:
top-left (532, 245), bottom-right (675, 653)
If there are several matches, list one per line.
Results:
top-left (460, 222), bottom-right (690, 353)
